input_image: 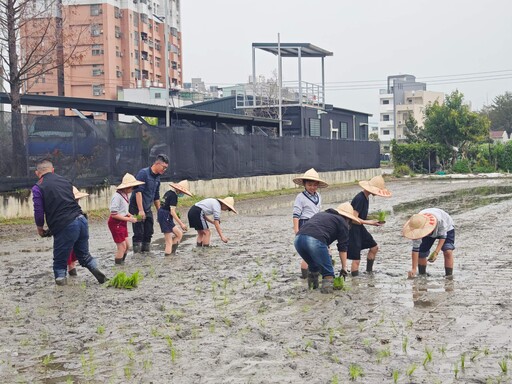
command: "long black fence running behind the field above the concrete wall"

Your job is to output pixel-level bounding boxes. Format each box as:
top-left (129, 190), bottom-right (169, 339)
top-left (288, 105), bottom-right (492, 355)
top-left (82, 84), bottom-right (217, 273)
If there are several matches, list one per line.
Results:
top-left (0, 112), bottom-right (380, 192)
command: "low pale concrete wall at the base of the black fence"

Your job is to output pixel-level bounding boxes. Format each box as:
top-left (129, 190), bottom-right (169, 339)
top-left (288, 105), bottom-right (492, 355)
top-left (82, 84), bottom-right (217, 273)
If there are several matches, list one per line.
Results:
top-left (0, 168), bottom-right (382, 219)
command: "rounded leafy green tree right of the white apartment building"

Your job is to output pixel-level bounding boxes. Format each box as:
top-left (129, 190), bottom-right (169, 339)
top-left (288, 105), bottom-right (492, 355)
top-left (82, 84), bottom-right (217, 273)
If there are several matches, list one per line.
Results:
top-left (424, 91), bottom-right (490, 164)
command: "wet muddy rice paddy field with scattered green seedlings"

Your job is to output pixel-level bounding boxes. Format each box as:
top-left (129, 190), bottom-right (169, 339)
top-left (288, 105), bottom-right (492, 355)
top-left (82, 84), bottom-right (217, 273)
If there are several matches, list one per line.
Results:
top-left (0, 179), bottom-right (512, 383)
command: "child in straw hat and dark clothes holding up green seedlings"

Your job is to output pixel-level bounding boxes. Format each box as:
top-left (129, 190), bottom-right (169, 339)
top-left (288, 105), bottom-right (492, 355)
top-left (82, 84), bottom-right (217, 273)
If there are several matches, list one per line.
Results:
top-left (348, 175), bottom-right (391, 276)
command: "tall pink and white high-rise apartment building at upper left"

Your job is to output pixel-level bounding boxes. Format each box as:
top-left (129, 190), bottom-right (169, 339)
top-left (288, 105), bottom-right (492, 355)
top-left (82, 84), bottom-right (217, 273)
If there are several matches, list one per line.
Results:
top-left (26, 0), bottom-right (183, 118)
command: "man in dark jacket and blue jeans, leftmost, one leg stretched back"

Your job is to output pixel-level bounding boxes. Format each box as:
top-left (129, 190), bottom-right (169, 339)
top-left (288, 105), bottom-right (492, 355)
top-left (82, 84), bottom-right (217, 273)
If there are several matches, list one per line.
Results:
top-left (32, 160), bottom-right (107, 285)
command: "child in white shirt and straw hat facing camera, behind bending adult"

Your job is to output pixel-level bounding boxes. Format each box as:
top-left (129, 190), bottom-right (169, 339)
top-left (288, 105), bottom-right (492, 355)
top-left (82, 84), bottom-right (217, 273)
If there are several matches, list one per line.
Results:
top-left (292, 168), bottom-right (329, 279)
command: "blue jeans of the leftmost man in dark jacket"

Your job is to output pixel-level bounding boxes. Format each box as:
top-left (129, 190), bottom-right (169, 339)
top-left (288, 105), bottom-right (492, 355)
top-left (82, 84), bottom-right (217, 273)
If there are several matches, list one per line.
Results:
top-left (53, 215), bottom-right (98, 278)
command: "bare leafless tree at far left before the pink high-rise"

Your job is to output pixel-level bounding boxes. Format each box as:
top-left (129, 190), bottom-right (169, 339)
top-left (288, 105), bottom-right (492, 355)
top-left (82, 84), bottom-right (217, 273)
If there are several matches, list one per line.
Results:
top-left (0, 0), bottom-right (88, 176)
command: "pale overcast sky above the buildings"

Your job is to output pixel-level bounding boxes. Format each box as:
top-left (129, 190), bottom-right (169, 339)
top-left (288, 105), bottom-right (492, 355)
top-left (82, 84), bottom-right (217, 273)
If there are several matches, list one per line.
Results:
top-left (181, 0), bottom-right (512, 121)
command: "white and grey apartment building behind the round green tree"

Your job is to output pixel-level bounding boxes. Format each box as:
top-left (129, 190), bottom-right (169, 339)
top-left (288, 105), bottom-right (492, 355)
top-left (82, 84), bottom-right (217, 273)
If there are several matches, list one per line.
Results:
top-left (378, 75), bottom-right (444, 153)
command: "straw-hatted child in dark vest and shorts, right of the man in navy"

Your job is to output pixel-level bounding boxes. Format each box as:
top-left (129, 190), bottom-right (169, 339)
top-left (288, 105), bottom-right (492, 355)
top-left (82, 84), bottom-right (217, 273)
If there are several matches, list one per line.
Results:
top-left (158, 180), bottom-right (193, 256)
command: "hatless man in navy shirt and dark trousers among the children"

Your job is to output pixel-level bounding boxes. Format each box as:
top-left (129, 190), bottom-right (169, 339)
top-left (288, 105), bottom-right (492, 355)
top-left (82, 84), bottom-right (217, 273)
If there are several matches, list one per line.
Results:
top-left (129, 154), bottom-right (169, 253)
